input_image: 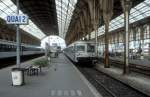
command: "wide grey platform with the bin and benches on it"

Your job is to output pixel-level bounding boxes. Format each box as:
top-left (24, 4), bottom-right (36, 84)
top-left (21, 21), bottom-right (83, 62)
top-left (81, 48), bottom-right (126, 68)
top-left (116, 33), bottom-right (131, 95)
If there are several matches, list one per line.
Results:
top-left (0, 54), bottom-right (102, 97)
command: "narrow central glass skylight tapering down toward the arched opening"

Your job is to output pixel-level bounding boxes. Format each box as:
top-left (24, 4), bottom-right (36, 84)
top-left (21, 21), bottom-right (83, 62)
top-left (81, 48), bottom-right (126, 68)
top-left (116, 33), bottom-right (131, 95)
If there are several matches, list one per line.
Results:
top-left (55, 0), bottom-right (77, 38)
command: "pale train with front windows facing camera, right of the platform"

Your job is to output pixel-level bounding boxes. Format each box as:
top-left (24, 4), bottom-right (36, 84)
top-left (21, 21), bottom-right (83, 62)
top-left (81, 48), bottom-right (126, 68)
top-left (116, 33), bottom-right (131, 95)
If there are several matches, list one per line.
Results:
top-left (64, 41), bottom-right (97, 63)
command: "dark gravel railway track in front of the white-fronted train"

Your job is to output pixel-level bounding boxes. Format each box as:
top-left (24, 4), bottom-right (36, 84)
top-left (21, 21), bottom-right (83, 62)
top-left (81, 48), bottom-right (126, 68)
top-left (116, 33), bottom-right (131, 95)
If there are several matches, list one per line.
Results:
top-left (77, 66), bottom-right (149, 97)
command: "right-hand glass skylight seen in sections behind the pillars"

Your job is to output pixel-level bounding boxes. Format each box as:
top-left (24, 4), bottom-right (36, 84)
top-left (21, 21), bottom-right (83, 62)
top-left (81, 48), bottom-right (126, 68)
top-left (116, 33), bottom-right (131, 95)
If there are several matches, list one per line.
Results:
top-left (91, 0), bottom-right (150, 38)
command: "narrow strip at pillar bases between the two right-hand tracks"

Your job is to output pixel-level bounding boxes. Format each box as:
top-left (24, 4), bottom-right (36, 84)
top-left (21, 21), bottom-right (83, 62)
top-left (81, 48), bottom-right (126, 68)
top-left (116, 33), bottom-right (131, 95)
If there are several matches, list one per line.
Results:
top-left (96, 63), bottom-right (150, 96)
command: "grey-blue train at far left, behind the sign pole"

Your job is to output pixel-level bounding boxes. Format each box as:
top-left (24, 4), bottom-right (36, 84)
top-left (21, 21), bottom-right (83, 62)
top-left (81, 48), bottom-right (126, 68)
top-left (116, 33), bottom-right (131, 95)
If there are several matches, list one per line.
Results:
top-left (0, 40), bottom-right (44, 59)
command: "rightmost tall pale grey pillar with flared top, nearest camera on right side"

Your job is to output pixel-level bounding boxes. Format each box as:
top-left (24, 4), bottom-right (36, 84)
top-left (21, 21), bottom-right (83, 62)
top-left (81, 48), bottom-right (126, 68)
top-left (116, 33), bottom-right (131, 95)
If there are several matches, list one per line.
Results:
top-left (121, 0), bottom-right (131, 74)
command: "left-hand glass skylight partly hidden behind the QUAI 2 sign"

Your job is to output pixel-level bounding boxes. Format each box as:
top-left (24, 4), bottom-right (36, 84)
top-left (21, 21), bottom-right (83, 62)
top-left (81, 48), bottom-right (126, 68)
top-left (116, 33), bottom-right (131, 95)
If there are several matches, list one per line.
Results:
top-left (0, 0), bottom-right (45, 39)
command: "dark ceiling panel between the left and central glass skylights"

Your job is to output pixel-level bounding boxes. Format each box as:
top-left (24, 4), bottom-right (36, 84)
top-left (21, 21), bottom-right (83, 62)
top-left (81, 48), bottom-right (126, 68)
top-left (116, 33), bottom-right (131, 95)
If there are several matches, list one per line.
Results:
top-left (12, 0), bottom-right (58, 35)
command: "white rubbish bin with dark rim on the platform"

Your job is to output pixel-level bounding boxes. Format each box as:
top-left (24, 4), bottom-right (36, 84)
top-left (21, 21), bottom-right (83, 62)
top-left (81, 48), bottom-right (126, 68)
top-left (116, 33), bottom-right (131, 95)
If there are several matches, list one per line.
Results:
top-left (11, 68), bottom-right (24, 86)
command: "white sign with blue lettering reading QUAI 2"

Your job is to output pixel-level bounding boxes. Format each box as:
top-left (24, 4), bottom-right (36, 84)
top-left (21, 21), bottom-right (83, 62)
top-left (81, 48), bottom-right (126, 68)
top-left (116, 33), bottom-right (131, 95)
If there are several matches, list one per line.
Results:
top-left (6, 15), bottom-right (29, 25)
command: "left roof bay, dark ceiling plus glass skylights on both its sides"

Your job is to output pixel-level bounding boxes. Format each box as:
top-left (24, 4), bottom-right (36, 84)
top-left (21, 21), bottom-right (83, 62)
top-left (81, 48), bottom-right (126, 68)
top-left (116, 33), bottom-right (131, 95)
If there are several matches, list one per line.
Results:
top-left (0, 0), bottom-right (77, 39)
